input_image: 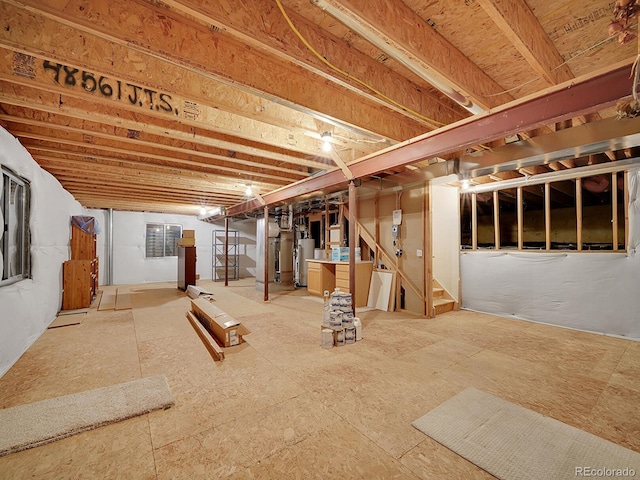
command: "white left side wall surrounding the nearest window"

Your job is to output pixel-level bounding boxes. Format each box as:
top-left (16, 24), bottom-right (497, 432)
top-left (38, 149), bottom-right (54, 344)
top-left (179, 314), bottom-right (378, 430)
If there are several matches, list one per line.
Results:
top-left (0, 127), bottom-right (84, 377)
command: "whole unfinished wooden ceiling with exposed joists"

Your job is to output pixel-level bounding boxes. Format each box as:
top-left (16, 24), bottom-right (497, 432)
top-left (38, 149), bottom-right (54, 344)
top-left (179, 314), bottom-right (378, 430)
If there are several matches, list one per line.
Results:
top-left (0, 0), bottom-right (638, 215)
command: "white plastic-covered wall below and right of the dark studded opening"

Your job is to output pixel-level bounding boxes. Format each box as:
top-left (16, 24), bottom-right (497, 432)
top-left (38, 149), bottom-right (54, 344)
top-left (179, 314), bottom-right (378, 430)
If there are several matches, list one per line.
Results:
top-left (460, 169), bottom-right (640, 340)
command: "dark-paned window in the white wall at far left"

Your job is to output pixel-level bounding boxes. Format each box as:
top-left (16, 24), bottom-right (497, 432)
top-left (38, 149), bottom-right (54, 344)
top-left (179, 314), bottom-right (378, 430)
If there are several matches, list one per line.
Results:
top-left (0, 167), bottom-right (31, 286)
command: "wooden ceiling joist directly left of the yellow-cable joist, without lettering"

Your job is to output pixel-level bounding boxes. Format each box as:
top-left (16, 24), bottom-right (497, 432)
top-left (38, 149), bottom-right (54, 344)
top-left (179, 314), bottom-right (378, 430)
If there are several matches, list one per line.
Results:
top-left (7, 0), bottom-right (424, 140)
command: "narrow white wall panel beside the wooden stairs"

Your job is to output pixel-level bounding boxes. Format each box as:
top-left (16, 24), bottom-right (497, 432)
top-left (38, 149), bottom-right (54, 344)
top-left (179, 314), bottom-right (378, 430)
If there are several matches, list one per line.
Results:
top-left (430, 175), bottom-right (460, 301)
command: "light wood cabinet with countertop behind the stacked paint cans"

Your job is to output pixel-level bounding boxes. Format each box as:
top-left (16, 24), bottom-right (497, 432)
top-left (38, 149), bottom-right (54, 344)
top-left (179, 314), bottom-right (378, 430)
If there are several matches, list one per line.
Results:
top-left (307, 260), bottom-right (373, 307)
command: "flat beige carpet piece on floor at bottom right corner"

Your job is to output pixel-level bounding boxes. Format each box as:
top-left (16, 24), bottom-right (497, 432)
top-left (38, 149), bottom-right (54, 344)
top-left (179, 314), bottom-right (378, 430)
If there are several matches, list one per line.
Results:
top-left (412, 387), bottom-right (640, 480)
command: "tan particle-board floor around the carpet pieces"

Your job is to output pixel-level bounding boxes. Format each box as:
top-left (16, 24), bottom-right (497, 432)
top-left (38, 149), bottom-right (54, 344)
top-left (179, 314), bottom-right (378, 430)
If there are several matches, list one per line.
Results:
top-left (0, 279), bottom-right (640, 480)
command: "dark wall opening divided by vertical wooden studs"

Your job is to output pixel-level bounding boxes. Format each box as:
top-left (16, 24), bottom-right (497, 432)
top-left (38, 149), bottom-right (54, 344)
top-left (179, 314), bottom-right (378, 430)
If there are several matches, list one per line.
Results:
top-left (460, 172), bottom-right (629, 252)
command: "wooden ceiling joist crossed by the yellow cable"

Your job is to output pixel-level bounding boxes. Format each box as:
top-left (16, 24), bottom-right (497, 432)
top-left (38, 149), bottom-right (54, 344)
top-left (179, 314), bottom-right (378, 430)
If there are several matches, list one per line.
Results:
top-left (156, 0), bottom-right (467, 130)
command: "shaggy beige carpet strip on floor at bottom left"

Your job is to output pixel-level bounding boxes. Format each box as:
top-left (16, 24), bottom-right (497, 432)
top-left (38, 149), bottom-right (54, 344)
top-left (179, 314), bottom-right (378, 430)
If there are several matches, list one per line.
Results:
top-left (0, 375), bottom-right (175, 456)
